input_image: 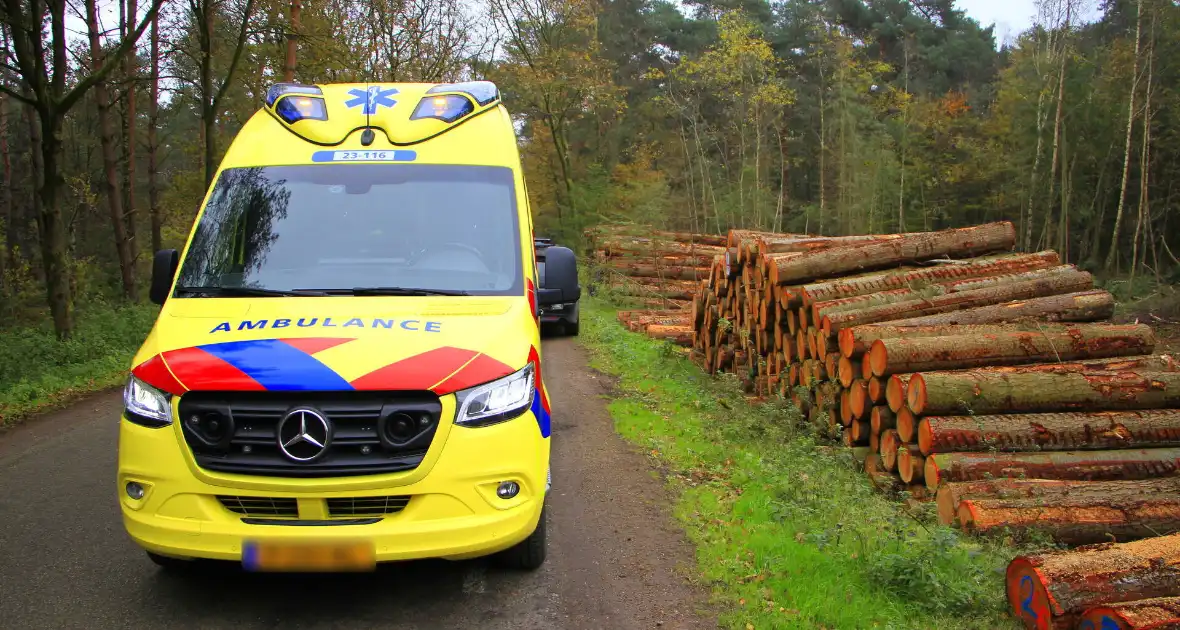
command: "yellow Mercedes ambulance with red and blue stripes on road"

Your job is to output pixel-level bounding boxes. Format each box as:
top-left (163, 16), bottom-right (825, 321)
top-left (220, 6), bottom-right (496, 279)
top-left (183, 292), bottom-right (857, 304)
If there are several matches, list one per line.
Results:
top-left (117, 81), bottom-right (577, 571)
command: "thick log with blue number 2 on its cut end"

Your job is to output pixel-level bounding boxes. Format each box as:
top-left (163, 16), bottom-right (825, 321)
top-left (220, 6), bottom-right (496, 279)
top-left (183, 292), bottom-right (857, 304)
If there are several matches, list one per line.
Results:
top-left (1004, 534), bottom-right (1180, 630)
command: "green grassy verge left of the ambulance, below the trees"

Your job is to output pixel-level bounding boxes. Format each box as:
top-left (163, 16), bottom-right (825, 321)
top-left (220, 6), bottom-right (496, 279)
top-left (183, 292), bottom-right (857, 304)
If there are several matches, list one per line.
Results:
top-left (0, 302), bottom-right (159, 427)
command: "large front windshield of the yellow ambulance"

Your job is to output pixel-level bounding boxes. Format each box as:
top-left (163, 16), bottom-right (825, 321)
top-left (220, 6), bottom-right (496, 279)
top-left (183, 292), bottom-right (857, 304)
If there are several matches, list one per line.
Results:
top-left (177, 164), bottom-right (523, 296)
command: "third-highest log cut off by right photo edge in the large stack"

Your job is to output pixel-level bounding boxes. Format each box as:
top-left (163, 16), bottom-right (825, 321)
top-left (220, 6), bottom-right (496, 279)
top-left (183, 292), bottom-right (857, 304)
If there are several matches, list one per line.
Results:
top-left (926, 448), bottom-right (1180, 490)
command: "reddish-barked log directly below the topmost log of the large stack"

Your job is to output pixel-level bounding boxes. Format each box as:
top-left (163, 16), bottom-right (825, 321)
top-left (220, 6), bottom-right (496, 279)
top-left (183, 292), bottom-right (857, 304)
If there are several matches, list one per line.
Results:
top-left (799, 251), bottom-right (1061, 306)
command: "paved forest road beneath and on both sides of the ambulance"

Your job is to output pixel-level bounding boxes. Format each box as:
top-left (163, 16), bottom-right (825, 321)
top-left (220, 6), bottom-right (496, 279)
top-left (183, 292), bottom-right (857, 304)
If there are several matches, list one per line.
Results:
top-left (0, 339), bottom-right (716, 630)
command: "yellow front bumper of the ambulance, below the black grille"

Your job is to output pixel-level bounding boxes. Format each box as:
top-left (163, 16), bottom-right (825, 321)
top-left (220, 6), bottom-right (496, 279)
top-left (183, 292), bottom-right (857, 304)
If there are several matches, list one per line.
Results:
top-left (117, 405), bottom-right (550, 562)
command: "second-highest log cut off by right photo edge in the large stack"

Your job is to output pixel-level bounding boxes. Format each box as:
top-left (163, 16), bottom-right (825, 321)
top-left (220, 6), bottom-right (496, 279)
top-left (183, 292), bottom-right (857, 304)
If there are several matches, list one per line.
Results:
top-left (918, 409), bottom-right (1180, 455)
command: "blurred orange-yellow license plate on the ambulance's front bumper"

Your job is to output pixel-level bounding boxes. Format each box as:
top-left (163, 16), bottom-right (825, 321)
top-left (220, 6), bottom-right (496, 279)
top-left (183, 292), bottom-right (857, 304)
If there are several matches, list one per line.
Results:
top-left (242, 542), bottom-right (376, 572)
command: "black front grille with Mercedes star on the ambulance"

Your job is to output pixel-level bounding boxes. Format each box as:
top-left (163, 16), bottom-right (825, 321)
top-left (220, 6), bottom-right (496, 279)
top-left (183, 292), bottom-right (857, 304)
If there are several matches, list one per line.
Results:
top-left (178, 392), bottom-right (443, 477)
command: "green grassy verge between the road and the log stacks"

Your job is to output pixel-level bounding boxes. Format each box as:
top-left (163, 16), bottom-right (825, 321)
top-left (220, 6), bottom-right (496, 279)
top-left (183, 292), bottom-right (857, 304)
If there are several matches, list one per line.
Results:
top-left (581, 298), bottom-right (1015, 629)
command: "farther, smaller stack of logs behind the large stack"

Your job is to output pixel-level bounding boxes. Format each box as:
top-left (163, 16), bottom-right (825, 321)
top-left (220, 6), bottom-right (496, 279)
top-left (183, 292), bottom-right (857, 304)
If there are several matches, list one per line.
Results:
top-left (586, 227), bottom-right (727, 348)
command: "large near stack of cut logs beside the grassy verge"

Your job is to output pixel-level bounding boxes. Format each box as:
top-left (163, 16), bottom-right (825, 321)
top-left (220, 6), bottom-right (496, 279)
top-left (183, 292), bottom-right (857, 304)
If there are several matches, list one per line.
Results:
top-left (674, 222), bottom-right (1180, 552)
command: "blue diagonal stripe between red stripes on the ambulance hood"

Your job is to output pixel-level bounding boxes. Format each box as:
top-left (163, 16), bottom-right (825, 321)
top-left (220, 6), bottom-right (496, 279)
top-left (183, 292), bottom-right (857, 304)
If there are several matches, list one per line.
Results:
top-left (201, 339), bottom-right (353, 392)
